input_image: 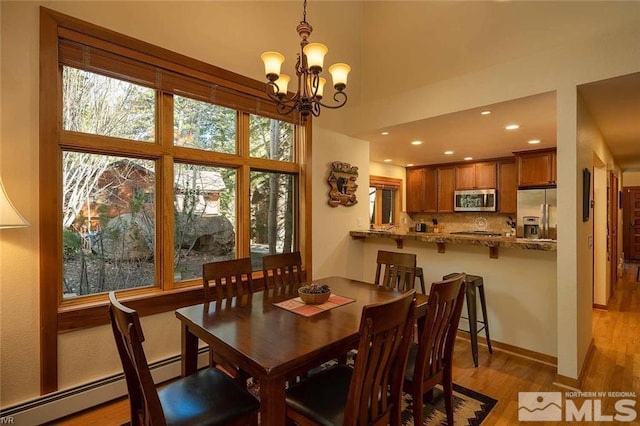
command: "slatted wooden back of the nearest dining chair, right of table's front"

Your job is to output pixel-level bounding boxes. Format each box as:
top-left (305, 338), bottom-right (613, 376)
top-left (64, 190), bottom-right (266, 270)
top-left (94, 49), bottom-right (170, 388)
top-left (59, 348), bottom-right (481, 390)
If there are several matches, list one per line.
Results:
top-left (344, 290), bottom-right (415, 425)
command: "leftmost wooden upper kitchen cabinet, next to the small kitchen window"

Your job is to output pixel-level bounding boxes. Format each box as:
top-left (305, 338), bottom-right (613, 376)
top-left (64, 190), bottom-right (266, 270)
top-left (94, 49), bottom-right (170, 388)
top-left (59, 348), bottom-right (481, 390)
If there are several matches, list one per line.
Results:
top-left (407, 167), bottom-right (438, 213)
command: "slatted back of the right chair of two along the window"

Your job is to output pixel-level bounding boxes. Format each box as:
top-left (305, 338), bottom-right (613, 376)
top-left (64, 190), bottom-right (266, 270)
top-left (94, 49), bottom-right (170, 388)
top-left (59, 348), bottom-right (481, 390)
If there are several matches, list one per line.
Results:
top-left (262, 251), bottom-right (304, 294)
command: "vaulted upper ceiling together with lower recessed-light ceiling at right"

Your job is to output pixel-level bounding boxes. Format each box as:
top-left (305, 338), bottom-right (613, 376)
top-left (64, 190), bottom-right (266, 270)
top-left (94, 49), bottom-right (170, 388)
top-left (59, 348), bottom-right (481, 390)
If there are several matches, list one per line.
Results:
top-left (338, 1), bottom-right (640, 170)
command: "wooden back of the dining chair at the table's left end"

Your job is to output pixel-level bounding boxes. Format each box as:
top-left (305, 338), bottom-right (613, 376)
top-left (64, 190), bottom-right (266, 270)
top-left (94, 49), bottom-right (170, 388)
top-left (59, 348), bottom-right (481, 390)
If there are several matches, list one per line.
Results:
top-left (109, 291), bottom-right (166, 425)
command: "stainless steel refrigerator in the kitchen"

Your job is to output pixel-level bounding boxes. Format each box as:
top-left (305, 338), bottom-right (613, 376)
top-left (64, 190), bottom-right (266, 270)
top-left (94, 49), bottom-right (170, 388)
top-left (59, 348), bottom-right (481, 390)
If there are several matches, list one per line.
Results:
top-left (516, 188), bottom-right (558, 240)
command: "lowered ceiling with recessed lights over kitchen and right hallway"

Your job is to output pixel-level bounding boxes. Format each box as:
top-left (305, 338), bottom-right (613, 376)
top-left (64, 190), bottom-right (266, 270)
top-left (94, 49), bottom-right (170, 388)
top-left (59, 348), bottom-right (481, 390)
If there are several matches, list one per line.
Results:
top-left (357, 73), bottom-right (640, 170)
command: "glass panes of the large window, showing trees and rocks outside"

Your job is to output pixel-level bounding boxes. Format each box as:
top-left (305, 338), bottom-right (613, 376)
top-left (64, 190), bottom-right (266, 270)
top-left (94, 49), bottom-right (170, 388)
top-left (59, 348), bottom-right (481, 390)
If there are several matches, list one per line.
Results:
top-left (56, 66), bottom-right (296, 299)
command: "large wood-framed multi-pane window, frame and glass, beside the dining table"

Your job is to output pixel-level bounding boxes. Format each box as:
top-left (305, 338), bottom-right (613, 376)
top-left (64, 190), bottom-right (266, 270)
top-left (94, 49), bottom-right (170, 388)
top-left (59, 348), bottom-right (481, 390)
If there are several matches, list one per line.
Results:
top-left (40, 8), bottom-right (311, 392)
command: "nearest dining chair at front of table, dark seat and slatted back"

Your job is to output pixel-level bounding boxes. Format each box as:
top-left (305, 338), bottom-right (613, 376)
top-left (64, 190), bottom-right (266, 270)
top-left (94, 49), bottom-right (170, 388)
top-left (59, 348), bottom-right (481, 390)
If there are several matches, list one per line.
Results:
top-left (286, 290), bottom-right (415, 426)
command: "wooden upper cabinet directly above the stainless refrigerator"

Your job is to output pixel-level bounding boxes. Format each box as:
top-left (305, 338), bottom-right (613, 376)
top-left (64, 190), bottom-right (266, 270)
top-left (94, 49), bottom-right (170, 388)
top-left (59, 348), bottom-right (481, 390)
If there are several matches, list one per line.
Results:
top-left (514, 148), bottom-right (556, 188)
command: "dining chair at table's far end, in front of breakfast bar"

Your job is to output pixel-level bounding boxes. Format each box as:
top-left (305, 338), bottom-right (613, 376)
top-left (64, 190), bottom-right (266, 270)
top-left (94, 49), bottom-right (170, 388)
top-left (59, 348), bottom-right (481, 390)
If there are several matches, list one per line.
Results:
top-left (374, 250), bottom-right (416, 291)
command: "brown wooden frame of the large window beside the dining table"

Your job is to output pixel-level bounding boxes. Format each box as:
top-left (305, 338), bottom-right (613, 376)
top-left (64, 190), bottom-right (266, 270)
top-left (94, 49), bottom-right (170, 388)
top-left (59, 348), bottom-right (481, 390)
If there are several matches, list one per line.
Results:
top-left (39, 7), bottom-right (312, 394)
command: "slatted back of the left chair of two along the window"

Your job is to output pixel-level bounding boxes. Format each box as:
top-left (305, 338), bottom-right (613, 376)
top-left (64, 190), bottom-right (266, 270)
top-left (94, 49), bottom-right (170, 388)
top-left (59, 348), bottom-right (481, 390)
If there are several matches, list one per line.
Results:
top-left (202, 257), bottom-right (253, 302)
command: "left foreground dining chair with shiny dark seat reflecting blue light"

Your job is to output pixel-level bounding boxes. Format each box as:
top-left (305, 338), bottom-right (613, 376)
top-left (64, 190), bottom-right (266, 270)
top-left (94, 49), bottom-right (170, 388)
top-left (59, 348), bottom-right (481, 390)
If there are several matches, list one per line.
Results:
top-left (109, 291), bottom-right (260, 426)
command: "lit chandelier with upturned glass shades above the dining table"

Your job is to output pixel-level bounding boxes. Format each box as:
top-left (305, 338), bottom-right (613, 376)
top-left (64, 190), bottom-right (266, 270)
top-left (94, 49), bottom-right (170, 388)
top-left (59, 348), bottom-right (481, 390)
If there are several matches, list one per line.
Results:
top-left (260, 0), bottom-right (351, 122)
